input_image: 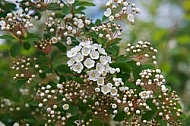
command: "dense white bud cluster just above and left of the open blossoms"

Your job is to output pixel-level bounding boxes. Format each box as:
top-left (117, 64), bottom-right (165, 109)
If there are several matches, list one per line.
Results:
top-left (45, 12), bottom-right (91, 45)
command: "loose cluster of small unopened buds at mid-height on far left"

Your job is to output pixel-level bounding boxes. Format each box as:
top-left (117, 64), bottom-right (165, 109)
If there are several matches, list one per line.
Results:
top-left (10, 57), bottom-right (43, 83)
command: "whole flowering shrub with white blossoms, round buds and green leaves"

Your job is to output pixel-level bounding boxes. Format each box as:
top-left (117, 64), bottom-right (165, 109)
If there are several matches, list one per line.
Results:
top-left (0, 0), bottom-right (183, 126)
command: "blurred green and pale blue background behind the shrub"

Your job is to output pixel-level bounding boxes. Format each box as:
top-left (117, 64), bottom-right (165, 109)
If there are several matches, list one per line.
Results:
top-left (0, 0), bottom-right (190, 126)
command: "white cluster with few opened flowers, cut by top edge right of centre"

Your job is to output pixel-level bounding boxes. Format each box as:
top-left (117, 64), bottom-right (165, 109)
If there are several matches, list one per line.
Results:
top-left (104, 0), bottom-right (140, 23)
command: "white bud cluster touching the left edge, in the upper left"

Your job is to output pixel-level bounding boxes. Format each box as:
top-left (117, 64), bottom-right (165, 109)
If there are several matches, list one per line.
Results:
top-left (0, 13), bottom-right (33, 37)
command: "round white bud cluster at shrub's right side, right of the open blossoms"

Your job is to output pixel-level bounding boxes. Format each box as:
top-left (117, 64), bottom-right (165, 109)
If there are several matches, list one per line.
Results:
top-left (126, 41), bottom-right (157, 66)
